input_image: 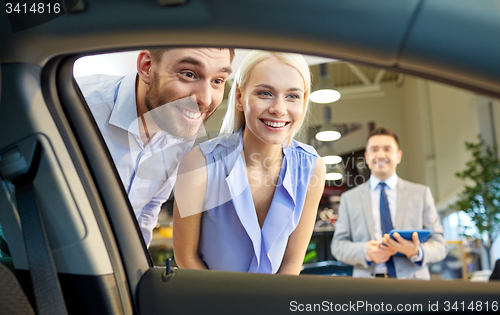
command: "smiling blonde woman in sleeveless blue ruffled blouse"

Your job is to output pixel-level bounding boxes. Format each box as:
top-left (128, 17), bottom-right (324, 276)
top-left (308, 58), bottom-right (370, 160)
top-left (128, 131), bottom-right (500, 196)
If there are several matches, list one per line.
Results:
top-left (173, 51), bottom-right (325, 275)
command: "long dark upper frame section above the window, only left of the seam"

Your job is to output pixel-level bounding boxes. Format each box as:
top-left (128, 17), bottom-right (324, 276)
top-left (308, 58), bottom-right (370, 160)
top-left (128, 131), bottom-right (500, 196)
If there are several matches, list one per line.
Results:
top-left (0, 0), bottom-right (422, 66)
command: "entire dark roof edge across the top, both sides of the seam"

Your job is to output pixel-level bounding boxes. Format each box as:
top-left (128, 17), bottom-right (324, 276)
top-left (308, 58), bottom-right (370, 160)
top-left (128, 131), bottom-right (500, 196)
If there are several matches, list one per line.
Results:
top-left (0, 0), bottom-right (500, 97)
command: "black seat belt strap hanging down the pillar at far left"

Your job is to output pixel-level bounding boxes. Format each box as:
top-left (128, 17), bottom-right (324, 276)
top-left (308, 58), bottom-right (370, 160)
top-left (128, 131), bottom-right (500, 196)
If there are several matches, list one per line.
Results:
top-left (11, 142), bottom-right (68, 315)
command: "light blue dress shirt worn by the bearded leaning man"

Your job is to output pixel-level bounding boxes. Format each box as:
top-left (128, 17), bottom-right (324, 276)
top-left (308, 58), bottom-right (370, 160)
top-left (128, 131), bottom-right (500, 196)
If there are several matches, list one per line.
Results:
top-left (76, 71), bottom-right (194, 246)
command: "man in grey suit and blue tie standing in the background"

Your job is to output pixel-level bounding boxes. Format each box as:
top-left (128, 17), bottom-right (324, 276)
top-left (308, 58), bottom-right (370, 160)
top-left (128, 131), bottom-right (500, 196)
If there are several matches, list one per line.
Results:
top-left (331, 128), bottom-right (447, 279)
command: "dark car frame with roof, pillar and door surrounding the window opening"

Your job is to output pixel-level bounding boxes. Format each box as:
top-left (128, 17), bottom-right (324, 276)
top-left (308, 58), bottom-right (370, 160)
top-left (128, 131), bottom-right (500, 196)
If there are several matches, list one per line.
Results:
top-left (0, 0), bottom-right (500, 314)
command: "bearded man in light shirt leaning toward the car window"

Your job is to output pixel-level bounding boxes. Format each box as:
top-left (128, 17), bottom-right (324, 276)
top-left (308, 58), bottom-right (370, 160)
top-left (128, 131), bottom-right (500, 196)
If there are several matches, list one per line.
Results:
top-left (77, 48), bottom-right (234, 246)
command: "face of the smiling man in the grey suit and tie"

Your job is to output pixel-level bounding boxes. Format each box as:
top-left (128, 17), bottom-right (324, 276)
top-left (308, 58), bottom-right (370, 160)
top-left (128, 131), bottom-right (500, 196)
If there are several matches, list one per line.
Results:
top-left (365, 135), bottom-right (403, 180)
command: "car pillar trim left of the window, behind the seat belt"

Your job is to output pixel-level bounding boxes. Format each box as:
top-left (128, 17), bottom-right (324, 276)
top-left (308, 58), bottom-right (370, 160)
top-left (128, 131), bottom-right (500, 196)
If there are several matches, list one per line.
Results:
top-left (0, 64), bottom-right (130, 314)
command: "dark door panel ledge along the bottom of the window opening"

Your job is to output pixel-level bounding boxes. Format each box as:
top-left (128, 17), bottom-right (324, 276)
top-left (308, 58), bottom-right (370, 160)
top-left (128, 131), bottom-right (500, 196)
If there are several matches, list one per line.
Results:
top-left (136, 268), bottom-right (500, 315)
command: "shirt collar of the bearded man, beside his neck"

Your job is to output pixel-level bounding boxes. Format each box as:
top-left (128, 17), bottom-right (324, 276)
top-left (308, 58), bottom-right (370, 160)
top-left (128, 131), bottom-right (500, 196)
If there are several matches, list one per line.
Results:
top-left (109, 71), bottom-right (139, 136)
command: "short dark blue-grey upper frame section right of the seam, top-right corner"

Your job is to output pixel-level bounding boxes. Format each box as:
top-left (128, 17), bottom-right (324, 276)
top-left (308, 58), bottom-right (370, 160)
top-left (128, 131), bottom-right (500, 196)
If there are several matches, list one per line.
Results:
top-left (399, 0), bottom-right (500, 96)
